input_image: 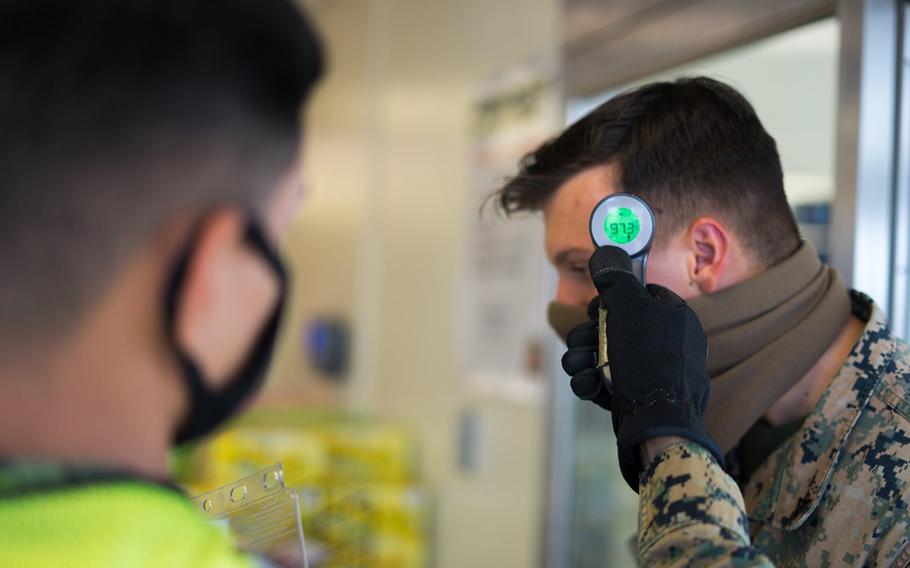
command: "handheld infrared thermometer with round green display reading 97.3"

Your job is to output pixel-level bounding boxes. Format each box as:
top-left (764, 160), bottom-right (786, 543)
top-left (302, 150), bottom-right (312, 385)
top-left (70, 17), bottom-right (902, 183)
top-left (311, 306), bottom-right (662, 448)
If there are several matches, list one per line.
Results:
top-left (590, 193), bottom-right (654, 384)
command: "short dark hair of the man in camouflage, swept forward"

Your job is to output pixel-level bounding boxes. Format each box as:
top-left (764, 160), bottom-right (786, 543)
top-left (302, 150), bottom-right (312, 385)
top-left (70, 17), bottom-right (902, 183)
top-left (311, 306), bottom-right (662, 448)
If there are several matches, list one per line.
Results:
top-left (498, 77), bottom-right (799, 266)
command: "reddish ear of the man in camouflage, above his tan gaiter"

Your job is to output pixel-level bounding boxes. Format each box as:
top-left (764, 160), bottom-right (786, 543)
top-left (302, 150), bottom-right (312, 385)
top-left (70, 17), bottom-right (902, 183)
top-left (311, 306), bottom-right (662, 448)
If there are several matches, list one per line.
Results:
top-left (686, 217), bottom-right (730, 294)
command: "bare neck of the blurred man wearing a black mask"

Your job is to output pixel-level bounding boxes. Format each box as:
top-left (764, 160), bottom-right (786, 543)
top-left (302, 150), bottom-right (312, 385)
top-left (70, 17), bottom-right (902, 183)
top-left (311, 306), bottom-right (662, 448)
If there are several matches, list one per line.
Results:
top-left (0, 251), bottom-right (186, 478)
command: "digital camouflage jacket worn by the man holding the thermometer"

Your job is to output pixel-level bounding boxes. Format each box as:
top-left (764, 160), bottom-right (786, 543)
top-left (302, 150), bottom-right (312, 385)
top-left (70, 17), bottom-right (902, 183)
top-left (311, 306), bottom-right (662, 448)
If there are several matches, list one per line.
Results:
top-left (638, 293), bottom-right (910, 567)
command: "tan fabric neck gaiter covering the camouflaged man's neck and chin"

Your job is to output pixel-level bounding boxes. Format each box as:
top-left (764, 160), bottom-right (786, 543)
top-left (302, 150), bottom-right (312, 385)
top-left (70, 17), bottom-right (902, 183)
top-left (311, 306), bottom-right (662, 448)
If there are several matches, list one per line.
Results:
top-left (548, 242), bottom-right (850, 453)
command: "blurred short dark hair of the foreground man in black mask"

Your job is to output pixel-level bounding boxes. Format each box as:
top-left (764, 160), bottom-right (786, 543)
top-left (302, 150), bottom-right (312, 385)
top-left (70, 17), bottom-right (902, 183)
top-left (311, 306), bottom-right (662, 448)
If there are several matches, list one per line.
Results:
top-left (0, 0), bottom-right (323, 352)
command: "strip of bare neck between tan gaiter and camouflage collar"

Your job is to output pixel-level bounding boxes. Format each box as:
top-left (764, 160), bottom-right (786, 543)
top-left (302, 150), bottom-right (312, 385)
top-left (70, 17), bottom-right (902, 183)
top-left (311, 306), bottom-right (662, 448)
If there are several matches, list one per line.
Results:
top-left (765, 316), bottom-right (866, 426)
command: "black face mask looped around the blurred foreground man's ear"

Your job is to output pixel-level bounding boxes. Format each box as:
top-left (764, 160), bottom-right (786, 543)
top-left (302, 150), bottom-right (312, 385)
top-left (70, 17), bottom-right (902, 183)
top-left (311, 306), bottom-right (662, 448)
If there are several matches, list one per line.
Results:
top-left (165, 220), bottom-right (288, 444)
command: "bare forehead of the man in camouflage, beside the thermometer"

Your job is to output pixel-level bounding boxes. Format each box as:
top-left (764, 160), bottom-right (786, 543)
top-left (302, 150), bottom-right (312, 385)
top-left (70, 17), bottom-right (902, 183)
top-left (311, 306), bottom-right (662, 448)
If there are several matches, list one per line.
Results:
top-left (543, 165), bottom-right (620, 259)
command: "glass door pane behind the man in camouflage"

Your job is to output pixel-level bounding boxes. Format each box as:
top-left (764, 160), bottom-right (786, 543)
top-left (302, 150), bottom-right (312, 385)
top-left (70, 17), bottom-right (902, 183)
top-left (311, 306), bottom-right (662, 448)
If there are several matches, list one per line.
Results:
top-left (551, 18), bottom-right (840, 568)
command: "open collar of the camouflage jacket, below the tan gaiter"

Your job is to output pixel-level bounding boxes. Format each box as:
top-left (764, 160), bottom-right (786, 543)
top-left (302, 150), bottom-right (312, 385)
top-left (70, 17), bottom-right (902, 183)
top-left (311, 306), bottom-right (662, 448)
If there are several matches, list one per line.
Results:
top-left (749, 292), bottom-right (897, 531)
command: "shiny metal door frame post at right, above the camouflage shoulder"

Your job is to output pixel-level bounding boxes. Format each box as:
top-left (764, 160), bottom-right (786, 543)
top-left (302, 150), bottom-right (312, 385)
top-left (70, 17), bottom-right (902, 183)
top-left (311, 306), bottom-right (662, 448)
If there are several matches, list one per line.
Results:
top-left (830, 0), bottom-right (906, 316)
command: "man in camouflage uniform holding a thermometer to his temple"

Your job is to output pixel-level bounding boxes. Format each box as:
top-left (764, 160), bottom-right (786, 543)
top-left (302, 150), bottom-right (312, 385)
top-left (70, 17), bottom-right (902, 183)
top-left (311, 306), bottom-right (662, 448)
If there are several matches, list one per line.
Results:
top-left (500, 78), bottom-right (910, 566)
